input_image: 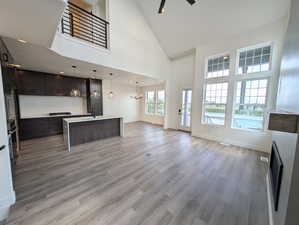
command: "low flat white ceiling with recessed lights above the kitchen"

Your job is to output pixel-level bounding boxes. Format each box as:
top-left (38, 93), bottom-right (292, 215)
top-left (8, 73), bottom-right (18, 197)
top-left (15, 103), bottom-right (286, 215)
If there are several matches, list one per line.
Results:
top-left (4, 38), bottom-right (163, 86)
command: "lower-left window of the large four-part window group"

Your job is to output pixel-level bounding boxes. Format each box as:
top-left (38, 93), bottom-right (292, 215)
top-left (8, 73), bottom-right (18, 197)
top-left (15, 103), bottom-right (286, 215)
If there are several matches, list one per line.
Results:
top-left (203, 82), bottom-right (228, 125)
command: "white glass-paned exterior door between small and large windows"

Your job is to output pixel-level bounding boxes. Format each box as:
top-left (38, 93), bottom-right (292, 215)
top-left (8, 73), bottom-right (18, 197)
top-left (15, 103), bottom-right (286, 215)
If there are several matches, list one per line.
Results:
top-left (179, 88), bottom-right (192, 131)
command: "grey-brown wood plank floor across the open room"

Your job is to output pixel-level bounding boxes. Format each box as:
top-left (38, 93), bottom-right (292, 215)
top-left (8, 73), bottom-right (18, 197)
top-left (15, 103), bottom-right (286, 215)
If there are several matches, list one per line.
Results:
top-left (7, 122), bottom-right (268, 225)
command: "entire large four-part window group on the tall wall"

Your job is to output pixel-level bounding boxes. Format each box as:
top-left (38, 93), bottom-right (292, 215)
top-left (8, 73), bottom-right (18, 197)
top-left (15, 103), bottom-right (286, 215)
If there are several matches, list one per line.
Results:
top-left (202, 43), bottom-right (273, 131)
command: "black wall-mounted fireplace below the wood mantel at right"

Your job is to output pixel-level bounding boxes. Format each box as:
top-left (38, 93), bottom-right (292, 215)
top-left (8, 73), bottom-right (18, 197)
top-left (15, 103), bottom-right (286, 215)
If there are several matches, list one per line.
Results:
top-left (269, 142), bottom-right (283, 211)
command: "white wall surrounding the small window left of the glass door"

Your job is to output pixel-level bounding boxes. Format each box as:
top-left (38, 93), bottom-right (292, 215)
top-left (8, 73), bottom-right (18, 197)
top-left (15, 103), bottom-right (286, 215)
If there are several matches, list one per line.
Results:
top-left (139, 84), bottom-right (167, 126)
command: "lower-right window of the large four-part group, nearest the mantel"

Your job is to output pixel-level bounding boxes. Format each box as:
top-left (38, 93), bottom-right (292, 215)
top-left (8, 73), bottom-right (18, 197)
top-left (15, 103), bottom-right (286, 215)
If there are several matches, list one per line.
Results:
top-left (232, 79), bottom-right (268, 130)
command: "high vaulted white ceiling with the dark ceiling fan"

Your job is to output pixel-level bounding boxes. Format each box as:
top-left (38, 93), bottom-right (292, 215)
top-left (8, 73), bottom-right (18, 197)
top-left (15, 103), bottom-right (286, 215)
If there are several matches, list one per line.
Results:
top-left (136, 0), bottom-right (290, 58)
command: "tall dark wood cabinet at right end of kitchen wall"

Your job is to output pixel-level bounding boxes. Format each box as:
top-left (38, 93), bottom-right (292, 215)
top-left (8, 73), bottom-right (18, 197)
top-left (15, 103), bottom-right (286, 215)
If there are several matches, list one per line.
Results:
top-left (87, 79), bottom-right (103, 116)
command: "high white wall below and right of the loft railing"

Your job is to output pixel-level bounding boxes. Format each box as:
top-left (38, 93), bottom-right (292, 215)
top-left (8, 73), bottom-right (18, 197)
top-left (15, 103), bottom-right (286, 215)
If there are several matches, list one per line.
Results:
top-left (51, 0), bottom-right (170, 80)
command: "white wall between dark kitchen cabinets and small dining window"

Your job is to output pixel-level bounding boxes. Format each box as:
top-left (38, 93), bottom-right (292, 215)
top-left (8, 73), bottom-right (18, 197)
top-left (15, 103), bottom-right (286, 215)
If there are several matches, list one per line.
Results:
top-left (103, 80), bottom-right (139, 123)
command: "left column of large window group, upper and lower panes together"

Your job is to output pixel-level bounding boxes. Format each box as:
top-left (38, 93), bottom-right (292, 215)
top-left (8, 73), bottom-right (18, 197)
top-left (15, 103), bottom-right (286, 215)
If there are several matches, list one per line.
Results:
top-left (202, 55), bottom-right (229, 125)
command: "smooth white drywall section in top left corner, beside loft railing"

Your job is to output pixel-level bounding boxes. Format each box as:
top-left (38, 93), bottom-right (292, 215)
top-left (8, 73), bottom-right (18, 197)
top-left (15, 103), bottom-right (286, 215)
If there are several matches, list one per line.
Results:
top-left (0, 0), bottom-right (66, 47)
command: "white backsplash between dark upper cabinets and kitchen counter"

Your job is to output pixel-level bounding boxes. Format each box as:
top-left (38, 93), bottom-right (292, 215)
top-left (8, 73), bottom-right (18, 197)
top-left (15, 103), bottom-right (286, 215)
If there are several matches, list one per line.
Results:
top-left (19, 95), bottom-right (87, 118)
